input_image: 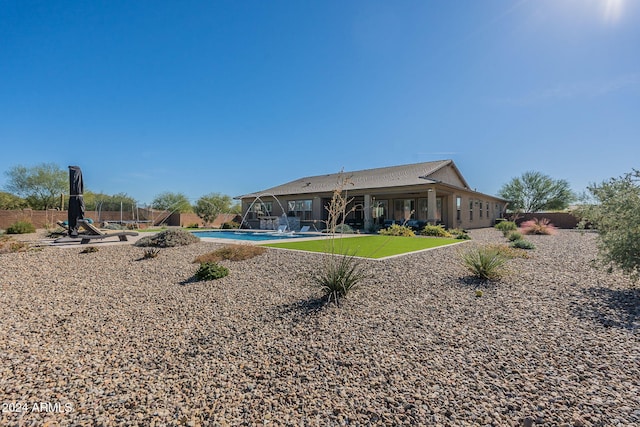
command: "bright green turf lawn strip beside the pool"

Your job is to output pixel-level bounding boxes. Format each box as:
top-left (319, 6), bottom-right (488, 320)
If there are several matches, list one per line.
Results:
top-left (262, 235), bottom-right (462, 258)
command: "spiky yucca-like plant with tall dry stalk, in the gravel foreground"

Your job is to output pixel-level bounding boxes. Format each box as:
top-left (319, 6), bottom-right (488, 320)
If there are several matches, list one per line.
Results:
top-left (312, 254), bottom-right (365, 304)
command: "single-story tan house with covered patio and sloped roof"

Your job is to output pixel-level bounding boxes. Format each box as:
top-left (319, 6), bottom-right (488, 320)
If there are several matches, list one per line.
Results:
top-left (236, 160), bottom-right (507, 230)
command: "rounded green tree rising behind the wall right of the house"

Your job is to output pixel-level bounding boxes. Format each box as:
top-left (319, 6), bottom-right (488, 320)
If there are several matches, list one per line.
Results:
top-left (498, 171), bottom-right (576, 213)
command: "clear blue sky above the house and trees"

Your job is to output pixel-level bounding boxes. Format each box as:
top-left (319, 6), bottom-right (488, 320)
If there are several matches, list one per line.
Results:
top-left (0, 0), bottom-right (640, 204)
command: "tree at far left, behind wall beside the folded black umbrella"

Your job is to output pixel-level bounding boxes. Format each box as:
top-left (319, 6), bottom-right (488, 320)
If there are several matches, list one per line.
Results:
top-left (5, 163), bottom-right (69, 209)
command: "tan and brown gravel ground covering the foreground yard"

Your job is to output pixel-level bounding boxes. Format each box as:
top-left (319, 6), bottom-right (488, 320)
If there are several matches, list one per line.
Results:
top-left (0, 229), bottom-right (640, 426)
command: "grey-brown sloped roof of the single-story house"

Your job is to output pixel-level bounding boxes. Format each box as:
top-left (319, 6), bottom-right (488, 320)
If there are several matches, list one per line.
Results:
top-left (237, 160), bottom-right (469, 199)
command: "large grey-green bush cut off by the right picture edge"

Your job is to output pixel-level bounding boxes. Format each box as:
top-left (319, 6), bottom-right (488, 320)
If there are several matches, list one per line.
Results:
top-left (576, 170), bottom-right (640, 282)
